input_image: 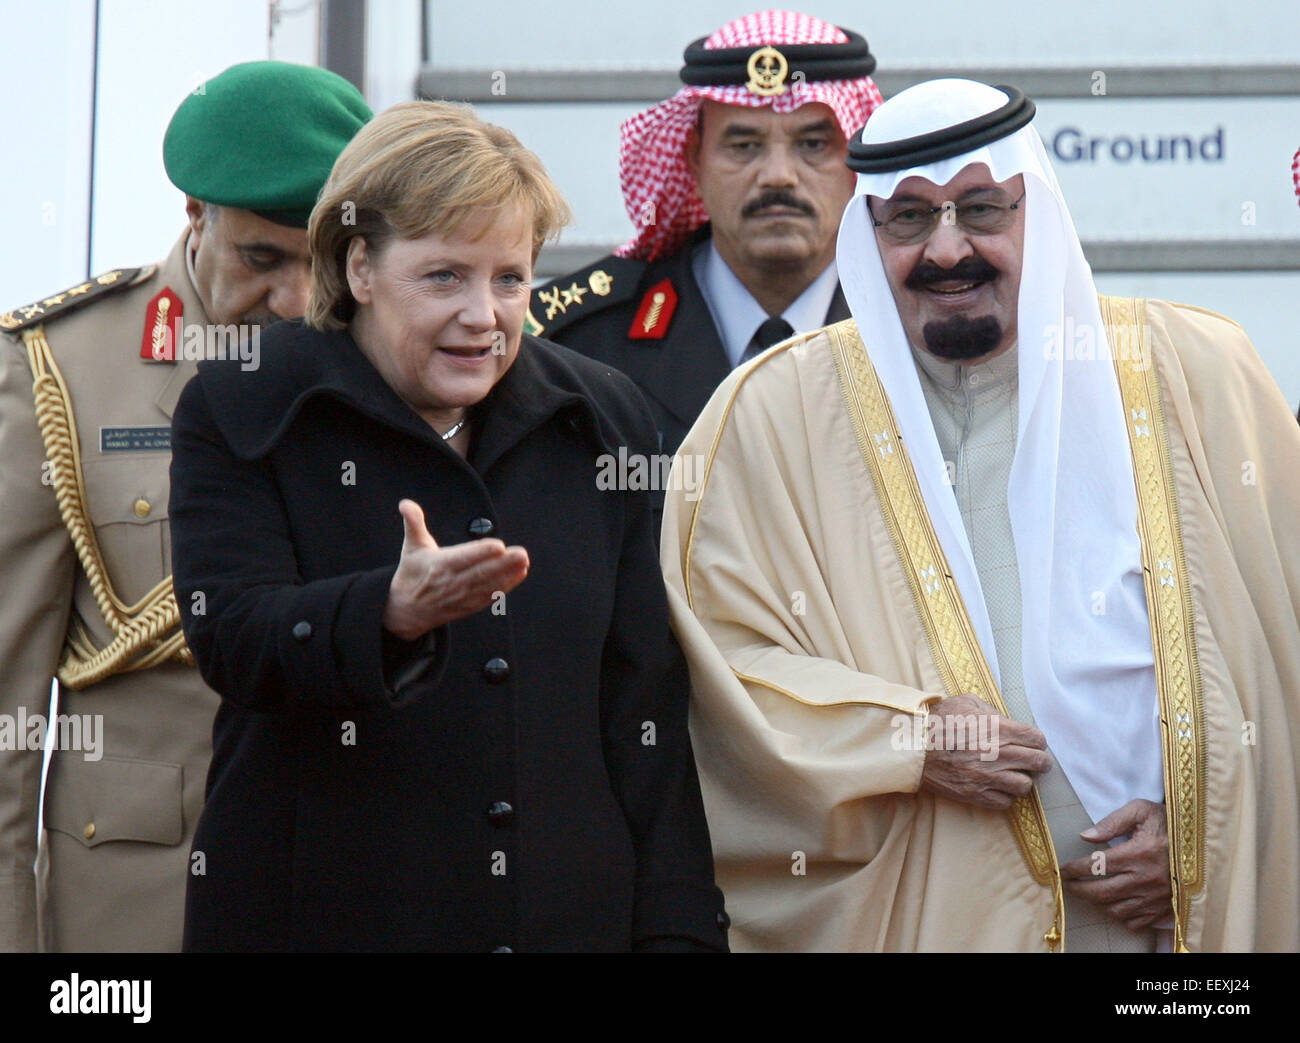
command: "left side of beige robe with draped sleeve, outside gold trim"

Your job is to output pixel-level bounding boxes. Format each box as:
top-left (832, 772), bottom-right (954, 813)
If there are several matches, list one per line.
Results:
top-left (662, 342), bottom-right (972, 949)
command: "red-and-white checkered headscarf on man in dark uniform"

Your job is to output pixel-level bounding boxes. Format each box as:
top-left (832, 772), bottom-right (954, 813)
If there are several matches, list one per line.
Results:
top-left (614, 10), bottom-right (881, 260)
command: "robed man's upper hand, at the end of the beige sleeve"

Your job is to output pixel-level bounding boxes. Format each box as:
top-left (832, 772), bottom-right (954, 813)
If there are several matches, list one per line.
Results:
top-left (920, 696), bottom-right (1052, 810)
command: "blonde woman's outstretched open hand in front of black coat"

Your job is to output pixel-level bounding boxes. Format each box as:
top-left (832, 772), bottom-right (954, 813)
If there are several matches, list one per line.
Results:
top-left (384, 499), bottom-right (528, 641)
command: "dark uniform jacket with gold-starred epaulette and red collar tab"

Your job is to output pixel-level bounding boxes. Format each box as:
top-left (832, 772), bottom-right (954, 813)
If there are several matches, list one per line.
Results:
top-left (530, 225), bottom-right (849, 454)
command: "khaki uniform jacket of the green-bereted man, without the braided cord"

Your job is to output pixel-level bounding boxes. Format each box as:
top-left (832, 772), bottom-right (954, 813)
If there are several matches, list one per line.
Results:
top-left (0, 235), bottom-right (218, 952)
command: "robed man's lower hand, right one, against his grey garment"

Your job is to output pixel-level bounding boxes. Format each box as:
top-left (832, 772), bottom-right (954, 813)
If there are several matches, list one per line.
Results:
top-left (1061, 800), bottom-right (1173, 931)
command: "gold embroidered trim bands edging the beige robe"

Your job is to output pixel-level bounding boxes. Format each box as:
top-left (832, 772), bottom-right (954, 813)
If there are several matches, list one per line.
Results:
top-left (829, 303), bottom-right (1205, 952)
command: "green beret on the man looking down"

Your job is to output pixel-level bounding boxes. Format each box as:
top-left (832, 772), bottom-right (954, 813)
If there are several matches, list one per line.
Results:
top-left (163, 61), bottom-right (373, 228)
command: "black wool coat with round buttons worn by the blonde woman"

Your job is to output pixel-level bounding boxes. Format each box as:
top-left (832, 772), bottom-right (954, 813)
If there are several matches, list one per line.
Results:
top-left (170, 323), bottom-right (727, 951)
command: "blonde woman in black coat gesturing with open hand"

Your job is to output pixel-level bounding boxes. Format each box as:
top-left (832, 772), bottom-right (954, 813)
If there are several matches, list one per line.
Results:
top-left (170, 101), bottom-right (727, 951)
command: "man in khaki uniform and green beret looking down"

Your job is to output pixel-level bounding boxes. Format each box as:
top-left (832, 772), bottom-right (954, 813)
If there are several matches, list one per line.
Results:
top-left (0, 61), bottom-right (371, 952)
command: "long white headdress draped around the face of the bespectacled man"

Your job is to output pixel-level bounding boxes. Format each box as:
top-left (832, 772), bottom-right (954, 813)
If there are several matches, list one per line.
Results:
top-left (836, 79), bottom-right (1164, 821)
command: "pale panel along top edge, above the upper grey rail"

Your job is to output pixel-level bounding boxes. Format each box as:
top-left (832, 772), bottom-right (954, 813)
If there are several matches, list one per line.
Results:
top-left (429, 0), bottom-right (1300, 69)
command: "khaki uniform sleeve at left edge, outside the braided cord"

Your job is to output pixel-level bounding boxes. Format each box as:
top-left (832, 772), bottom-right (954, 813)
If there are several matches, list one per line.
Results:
top-left (0, 337), bottom-right (77, 952)
